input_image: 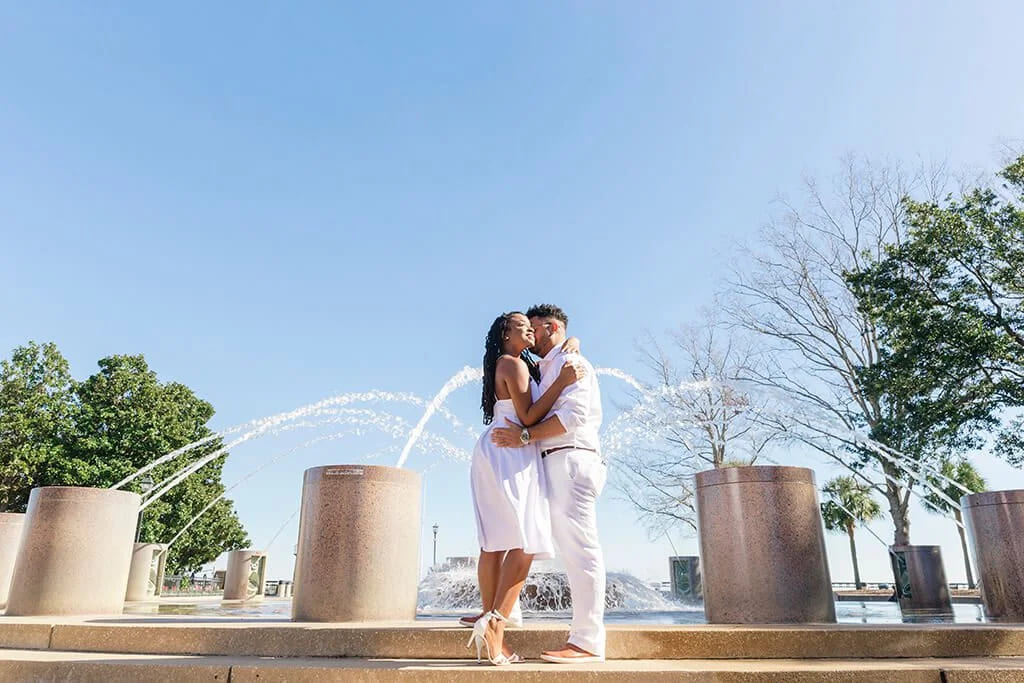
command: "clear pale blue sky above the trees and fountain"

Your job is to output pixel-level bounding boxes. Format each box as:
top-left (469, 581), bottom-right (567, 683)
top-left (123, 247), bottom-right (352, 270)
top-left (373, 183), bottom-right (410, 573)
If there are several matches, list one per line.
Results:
top-left (0, 1), bottom-right (1024, 581)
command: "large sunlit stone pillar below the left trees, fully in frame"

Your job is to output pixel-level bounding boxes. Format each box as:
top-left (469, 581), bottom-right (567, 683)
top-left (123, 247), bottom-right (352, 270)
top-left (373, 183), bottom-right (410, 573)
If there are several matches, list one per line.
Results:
top-left (7, 486), bottom-right (141, 616)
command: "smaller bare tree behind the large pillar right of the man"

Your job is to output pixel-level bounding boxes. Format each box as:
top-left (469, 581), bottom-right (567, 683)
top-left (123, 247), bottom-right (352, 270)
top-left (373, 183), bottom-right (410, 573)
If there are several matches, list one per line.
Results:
top-left (606, 315), bottom-right (773, 533)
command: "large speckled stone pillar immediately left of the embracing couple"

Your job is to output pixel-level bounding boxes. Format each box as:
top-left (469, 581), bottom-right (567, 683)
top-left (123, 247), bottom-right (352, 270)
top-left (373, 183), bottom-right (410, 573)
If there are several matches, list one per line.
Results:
top-left (292, 465), bottom-right (421, 622)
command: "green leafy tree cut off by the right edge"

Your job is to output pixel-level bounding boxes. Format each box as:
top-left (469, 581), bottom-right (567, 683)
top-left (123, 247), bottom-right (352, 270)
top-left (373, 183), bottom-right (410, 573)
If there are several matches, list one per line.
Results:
top-left (852, 156), bottom-right (1024, 466)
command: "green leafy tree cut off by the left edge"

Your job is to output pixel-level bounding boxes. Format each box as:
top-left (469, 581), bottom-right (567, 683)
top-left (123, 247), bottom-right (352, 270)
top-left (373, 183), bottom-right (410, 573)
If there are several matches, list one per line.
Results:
top-left (0, 342), bottom-right (74, 512)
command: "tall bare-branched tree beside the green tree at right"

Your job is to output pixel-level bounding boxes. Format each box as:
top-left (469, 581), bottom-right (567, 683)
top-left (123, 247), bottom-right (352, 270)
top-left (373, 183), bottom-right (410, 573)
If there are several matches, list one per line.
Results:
top-left (725, 158), bottom-right (948, 544)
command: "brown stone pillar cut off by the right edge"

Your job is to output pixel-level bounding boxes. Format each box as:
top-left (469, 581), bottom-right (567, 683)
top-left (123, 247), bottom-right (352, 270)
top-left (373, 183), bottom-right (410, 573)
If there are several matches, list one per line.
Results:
top-left (961, 489), bottom-right (1024, 624)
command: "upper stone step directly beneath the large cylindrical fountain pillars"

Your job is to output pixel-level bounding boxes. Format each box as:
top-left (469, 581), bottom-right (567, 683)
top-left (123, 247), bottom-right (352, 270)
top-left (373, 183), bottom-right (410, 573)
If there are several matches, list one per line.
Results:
top-left (6, 616), bottom-right (1024, 659)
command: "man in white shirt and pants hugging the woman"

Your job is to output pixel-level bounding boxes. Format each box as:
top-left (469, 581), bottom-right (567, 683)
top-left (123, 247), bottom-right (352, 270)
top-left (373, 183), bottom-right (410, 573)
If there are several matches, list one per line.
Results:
top-left (492, 304), bottom-right (607, 664)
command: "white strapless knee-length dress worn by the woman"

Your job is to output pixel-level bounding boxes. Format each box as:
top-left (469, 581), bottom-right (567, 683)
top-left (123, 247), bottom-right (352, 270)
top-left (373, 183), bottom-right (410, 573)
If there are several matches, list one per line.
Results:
top-left (469, 398), bottom-right (555, 559)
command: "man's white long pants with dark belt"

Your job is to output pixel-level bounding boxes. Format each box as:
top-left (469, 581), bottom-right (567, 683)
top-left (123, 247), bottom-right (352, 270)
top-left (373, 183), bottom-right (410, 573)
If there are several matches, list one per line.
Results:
top-left (544, 449), bottom-right (607, 657)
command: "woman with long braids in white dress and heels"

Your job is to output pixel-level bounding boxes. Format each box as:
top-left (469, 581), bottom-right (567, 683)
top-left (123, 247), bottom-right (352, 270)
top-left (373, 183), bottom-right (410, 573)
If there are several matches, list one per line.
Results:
top-left (469, 312), bottom-right (582, 665)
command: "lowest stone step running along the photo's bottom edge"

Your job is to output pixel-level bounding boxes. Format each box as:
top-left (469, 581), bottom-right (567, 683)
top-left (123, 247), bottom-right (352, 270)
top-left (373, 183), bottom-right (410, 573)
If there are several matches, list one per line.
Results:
top-left (0, 649), bottom-right (1024, 683)
